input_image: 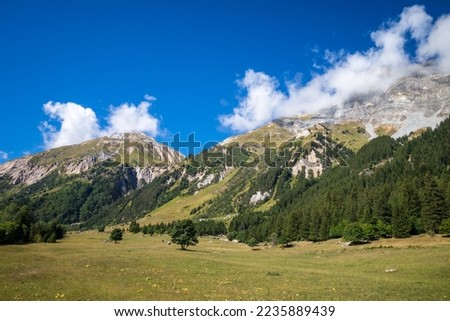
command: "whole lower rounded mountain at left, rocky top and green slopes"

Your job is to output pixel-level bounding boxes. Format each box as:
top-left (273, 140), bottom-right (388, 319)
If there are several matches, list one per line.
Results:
top-left (0, 133), bottom-right (184, 227)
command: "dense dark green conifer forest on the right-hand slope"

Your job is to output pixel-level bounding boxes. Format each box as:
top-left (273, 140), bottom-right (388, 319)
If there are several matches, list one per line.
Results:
top-left (230, 119), bottom-right (450, 243)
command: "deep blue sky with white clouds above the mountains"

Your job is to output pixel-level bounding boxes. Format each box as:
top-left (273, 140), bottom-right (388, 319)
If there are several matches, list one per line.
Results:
top-left (0, 0), bottom-right (450, 162)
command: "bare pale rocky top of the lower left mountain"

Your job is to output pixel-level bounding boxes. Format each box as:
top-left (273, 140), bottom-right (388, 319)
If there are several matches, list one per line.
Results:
top-left (0, 133), bottom-right (184, 185)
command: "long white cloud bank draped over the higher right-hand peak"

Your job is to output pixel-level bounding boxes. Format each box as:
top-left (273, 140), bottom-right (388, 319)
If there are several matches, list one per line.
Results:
top-left (219, 5), bottom-right (450, 132)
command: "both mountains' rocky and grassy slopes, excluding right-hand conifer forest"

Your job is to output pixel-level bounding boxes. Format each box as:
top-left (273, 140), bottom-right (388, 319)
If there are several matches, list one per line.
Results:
top-left (0, 75), bottom-right (450, 235)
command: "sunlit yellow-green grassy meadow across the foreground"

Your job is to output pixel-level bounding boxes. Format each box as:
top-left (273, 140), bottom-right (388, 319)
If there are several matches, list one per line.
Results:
top-left (0, 232), bottom-right (450, 300)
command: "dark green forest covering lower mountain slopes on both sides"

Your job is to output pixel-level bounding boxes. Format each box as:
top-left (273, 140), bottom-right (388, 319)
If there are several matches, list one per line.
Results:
top-left (0, 119), bottom-right (450, 246)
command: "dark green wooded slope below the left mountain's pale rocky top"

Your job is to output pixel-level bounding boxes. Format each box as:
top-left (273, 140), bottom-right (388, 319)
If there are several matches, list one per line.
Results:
top-left (0, 163), bottom-right (186, 229)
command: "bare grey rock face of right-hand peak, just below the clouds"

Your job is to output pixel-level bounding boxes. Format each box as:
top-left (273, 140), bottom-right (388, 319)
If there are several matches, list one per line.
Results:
top-left (274, 75), bottom-right (450, 138)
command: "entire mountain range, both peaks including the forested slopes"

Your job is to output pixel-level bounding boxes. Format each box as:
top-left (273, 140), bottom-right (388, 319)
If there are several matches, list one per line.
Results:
top-left (0, 75), bottom-right (450, 242)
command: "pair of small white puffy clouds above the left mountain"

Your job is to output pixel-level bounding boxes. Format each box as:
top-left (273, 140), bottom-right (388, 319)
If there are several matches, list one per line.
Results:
top-left (39, 95), bottom-right (159, 148)
